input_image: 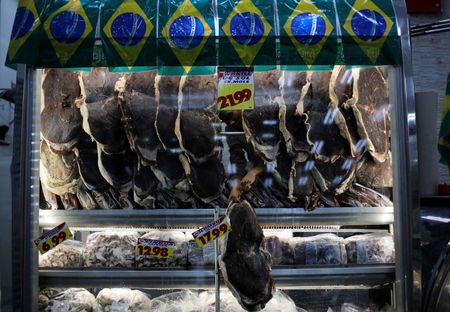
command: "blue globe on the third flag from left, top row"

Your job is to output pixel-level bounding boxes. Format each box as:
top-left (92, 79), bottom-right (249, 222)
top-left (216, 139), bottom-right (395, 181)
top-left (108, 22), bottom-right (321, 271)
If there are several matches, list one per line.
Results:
top-left (111, 12), bottom-right (147, 46)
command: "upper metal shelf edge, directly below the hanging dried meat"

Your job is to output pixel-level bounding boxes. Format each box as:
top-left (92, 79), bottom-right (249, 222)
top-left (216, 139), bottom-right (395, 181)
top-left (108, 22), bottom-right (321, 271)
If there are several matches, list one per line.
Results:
top-left (39, 207), bottom-right (394, 229)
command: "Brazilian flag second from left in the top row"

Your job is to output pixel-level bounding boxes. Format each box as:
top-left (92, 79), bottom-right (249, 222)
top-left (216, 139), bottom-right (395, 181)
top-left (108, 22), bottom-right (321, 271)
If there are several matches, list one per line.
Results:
top-left (36, 0), bottom-right (99, 68)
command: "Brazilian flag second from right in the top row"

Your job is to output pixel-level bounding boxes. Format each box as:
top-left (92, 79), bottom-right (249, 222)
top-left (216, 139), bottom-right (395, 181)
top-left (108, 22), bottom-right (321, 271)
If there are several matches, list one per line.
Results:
top-left (278, 0), bottom-right (337, 70)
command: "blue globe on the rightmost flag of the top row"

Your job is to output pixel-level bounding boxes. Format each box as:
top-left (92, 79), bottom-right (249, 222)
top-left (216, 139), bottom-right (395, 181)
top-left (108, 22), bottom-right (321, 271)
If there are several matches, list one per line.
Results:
top-left (351, 10), bottom-right (387, 42)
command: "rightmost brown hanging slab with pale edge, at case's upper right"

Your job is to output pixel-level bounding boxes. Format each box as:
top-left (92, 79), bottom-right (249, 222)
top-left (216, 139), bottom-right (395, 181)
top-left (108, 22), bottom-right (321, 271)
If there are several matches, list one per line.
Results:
top-left (345, 67), bottom-right (390, 163)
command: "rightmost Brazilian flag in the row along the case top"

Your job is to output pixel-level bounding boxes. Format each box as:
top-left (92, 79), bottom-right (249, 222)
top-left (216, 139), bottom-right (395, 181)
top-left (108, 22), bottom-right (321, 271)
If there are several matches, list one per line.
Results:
top-left (336, 0), bottom-right (401, 65)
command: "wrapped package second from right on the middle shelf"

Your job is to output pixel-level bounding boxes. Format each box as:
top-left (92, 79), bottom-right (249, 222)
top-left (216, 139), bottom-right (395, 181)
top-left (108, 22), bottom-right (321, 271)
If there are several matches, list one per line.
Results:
top-left (292, 234), bottom-right (347, 264)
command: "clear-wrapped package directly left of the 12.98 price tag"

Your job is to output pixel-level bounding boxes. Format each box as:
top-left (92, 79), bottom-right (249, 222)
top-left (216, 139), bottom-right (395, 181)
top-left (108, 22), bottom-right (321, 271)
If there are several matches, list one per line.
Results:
top-left (83, 231), bottom-right (140, 268)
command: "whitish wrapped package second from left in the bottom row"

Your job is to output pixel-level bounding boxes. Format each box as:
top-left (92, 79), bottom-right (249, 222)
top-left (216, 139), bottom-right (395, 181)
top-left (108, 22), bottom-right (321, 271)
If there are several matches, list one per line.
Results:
top-left (93, 288), bottom-right (152, 312)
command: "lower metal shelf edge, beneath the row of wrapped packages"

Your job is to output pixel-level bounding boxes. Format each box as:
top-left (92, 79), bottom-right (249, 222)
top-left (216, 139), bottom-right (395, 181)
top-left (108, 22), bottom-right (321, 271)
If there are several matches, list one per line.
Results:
top-left (39, 264), bottom-right (395, 289)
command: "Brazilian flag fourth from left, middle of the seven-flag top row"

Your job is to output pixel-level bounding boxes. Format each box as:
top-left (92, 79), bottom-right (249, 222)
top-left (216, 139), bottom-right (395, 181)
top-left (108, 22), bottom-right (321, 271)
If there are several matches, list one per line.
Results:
top-left (157, 0), bottom-right (216, 75)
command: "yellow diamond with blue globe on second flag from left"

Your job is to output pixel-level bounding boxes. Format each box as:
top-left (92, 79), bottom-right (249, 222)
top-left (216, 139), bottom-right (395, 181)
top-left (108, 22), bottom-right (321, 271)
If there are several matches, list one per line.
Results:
top-left (44, 0), bottom-right (93, 66)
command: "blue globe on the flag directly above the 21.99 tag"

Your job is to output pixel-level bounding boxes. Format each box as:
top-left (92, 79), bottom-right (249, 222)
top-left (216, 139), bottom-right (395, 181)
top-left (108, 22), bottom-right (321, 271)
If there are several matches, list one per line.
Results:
top-left (230, 12), bottom-right (264, 46)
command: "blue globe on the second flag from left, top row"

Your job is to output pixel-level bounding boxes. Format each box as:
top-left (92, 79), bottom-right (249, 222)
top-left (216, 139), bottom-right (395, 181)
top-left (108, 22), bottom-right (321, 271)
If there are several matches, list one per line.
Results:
top-left (50, 11), bottom-right (86, 44)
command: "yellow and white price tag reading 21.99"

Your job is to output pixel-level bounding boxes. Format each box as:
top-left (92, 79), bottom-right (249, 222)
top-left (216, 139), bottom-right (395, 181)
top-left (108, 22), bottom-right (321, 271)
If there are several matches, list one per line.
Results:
top-left (217, 69), bottom-right (254, 110)
